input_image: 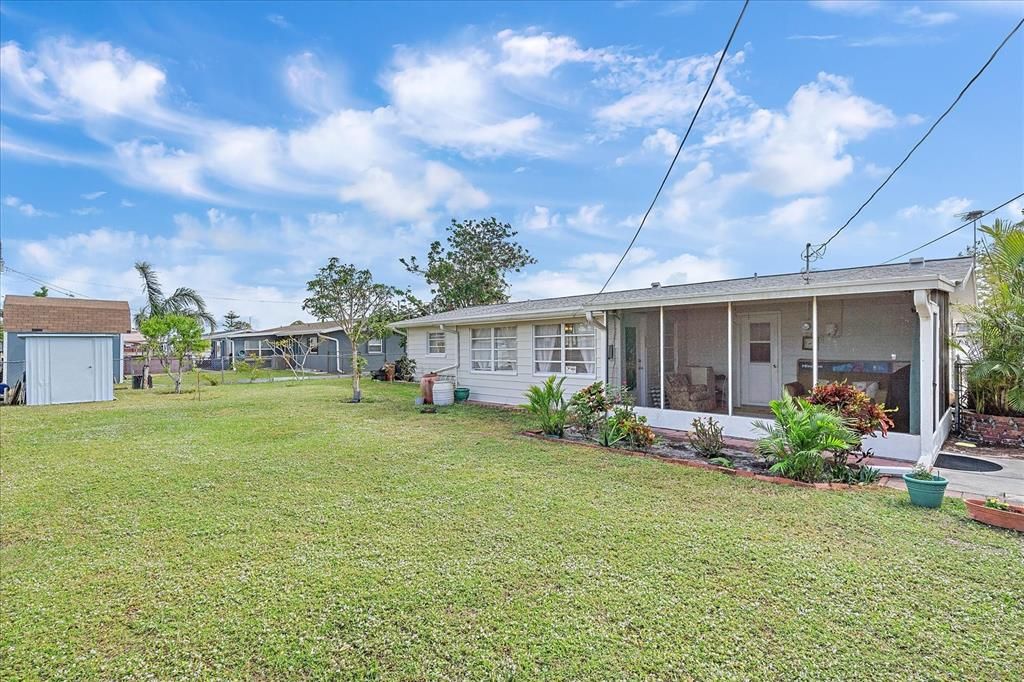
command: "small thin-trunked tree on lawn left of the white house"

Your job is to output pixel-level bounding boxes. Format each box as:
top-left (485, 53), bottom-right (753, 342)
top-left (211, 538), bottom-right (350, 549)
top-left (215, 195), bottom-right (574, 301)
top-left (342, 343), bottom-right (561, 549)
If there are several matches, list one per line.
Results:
top-left (302, 258), bottom-right (404, 402)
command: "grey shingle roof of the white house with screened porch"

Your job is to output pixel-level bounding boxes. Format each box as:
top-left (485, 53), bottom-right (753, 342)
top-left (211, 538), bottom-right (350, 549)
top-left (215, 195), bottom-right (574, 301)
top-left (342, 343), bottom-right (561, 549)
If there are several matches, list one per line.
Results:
top-left (393, 258), bottom-right (972, 327)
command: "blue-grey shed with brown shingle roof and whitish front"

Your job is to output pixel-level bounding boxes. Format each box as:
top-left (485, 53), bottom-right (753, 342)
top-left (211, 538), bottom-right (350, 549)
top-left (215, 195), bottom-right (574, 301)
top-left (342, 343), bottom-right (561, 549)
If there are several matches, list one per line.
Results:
top-left (3, 296), bottom-right (131, 404)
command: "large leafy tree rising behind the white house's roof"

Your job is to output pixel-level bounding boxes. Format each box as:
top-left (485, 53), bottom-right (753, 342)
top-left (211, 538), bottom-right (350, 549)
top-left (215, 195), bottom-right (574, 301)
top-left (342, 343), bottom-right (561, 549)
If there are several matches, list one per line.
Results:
top-left (399, 217), bottom-right (537, 313)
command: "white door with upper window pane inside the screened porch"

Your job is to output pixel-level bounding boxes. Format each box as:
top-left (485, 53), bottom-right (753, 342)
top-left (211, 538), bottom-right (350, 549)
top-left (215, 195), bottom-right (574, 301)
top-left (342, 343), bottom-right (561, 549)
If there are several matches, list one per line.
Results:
top-left (739, 312), bottom-right (782, 406)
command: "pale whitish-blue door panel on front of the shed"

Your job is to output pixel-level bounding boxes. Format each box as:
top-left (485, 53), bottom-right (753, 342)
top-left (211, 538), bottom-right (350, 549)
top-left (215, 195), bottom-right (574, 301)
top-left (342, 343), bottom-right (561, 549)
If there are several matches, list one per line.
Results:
top-left (26, 336), bottom-right (114, 404)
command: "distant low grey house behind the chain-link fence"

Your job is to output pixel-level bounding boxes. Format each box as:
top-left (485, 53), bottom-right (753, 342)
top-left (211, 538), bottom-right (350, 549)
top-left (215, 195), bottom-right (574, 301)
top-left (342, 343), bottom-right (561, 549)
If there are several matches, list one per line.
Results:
top-left (205, 323), bottom-right (406, 374)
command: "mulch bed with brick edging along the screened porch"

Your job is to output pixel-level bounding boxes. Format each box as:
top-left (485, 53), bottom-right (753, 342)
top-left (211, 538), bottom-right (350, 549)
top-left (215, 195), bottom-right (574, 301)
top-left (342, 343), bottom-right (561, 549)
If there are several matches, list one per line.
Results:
top-left (521, 431), bottom-right (890, 491)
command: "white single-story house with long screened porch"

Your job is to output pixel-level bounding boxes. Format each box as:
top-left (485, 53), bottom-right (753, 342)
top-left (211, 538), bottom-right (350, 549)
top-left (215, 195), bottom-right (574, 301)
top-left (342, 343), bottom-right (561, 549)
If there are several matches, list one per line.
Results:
top-left (394, 258), bottom-right (974, 463)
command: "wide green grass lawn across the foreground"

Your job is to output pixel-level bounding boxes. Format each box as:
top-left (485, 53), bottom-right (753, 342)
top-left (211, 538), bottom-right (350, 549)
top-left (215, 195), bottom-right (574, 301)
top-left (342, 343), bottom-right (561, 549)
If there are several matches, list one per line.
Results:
top-left (0, 380), bottom-right (1024, 680)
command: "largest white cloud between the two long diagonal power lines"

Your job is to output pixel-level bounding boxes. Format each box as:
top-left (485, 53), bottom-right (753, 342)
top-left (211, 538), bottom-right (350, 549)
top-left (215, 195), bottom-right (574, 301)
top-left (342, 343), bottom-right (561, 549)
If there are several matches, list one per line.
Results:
top-left (705, 73), bottom-right (897, 196)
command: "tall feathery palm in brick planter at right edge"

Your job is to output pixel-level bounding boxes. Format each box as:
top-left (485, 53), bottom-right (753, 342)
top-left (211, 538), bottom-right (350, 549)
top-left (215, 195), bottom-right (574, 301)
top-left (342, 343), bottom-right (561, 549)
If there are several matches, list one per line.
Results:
top-left (952, 215), bottom-right (1024, 415)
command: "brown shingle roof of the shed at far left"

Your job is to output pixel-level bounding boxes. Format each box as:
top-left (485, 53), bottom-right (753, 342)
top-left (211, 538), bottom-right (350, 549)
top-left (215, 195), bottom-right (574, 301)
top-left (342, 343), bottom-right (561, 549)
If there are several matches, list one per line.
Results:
top-left (3, 294), bottom-right (131, 334)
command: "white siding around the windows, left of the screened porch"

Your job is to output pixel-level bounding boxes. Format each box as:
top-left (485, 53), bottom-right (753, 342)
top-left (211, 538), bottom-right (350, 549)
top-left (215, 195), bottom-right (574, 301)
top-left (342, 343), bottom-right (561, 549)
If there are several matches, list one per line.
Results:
top-left (407, 318), bottom-right (606, 406)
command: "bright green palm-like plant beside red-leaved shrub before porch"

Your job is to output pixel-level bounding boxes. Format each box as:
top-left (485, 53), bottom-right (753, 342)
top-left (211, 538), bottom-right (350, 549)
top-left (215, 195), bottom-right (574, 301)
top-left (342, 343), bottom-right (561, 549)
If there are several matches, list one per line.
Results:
top-left (754, 392), bottom-right (860, 482)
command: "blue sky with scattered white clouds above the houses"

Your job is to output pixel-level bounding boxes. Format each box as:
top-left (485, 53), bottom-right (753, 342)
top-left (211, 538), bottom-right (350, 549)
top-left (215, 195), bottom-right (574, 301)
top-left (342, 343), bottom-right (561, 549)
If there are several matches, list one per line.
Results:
top-left (0, 2), bottom-right (1024, 326)
